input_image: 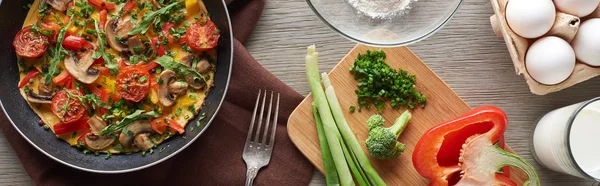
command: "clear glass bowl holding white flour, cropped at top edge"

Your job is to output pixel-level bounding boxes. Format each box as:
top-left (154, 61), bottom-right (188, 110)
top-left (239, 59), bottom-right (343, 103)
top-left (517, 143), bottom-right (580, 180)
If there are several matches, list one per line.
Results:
top-left (306, 0), bottom-right (462, 47)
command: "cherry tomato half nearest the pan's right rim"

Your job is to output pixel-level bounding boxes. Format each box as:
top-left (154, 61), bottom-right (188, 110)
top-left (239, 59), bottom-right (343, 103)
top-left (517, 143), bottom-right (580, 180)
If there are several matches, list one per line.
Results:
top-left (184, 20), bottom-right (221, 52)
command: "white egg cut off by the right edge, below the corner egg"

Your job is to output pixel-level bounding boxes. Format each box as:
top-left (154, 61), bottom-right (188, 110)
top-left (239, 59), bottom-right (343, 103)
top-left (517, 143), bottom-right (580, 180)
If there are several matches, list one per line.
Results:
top-left (571, 18), bottom-right (600, 66)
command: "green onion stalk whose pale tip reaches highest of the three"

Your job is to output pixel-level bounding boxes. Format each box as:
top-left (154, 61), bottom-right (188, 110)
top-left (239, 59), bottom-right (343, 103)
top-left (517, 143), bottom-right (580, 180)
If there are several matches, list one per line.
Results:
top-left (306, 45), bottom-right (354, 186)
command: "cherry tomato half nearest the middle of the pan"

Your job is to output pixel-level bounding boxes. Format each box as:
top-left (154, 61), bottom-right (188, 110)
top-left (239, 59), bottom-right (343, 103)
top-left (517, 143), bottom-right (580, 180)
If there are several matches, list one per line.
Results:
top-left (117, 66), bottom-right (150, 102)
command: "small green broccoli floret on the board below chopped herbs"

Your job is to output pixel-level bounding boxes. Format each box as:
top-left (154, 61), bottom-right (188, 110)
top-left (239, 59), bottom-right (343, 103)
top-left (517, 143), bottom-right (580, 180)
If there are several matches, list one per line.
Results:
top-left (366, 110), bottom-right (411, 159)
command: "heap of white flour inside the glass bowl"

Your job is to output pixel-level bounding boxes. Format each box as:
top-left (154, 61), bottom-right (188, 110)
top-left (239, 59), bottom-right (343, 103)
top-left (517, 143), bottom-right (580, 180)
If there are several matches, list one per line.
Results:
top-left (348, 0), bottom-right (416, 19)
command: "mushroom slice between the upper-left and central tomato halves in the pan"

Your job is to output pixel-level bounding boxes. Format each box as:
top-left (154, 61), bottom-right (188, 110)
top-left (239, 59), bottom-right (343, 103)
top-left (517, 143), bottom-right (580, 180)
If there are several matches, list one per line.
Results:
top-left (64, 51), bottom-right (100, 84)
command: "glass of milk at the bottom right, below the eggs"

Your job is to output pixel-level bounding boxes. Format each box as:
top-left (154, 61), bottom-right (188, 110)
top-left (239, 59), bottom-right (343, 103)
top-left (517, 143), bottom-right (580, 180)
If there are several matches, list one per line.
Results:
top-left (531, 97), bottom-right (600, 181)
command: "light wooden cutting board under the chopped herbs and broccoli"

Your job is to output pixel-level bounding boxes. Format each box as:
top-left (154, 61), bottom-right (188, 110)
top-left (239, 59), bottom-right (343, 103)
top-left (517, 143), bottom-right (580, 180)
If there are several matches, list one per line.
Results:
top-left (288, 45), bottom-right (527, 185)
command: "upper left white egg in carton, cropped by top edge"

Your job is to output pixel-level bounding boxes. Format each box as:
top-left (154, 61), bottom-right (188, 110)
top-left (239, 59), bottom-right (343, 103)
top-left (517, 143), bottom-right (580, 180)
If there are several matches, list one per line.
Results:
top-left (506, 0), bottom-right (556, 38)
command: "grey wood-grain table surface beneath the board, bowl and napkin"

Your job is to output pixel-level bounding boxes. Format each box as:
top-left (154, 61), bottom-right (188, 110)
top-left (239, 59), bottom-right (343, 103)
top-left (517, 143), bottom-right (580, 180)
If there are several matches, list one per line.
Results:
top-left (0, 0), bottom-right (600, 185)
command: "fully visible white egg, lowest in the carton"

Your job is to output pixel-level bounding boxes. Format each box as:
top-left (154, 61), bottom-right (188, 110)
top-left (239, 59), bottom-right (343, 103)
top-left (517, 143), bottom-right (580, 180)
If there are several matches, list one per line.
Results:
top-left (525, 36), bottom-right (575, 85)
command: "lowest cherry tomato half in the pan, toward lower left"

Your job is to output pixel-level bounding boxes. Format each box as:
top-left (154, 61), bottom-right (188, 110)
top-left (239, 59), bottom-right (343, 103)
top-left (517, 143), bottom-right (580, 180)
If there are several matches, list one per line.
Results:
top-left (50, 89), bottom-right (85, 123)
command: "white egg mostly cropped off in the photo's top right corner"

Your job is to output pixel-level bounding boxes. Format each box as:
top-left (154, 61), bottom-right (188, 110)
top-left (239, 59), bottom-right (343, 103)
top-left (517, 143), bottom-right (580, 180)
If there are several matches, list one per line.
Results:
top-left (554, 0), bottom-right (600, 17)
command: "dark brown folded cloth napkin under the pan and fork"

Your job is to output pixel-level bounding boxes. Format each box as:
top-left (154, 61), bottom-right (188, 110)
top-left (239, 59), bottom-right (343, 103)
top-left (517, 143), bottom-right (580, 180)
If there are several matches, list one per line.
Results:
top-left (0, 0), bottom-right (314, 185)
